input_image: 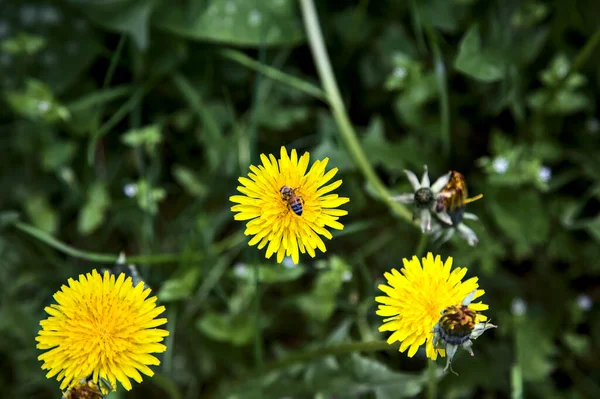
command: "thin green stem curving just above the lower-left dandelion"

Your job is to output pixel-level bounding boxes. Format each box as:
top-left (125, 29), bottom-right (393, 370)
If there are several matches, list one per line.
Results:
top-left (14, 222), bottom-right (245, 265)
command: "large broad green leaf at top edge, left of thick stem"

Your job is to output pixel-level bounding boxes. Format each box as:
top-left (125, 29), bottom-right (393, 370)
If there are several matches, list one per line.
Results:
top-left (153, 0), bottom-right (304, 47)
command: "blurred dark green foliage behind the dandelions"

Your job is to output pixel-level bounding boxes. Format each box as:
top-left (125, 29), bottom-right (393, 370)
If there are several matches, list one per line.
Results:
top-left (0, 0), bottom-right (600, 399)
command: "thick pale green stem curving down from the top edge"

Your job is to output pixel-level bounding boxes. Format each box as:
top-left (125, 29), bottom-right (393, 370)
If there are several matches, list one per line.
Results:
top-left (300, 0), bottom-right (412, 223)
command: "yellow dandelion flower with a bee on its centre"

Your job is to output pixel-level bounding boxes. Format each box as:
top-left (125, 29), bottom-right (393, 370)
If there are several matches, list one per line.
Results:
top-left (229, 147), bottom-right (350, 263)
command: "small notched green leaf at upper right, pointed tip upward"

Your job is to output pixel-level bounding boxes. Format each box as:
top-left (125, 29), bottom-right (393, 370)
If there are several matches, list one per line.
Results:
top-left (454, 24), bottom-right (505, 82)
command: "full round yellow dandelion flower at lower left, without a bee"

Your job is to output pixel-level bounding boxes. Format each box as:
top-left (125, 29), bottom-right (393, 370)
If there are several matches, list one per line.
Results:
top-left (36, 270), bottom-right (169, 390)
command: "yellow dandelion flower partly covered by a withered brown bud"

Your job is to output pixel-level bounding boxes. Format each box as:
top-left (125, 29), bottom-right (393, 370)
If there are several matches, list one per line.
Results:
top-left (375, 252), bottom-right (495, 360)
